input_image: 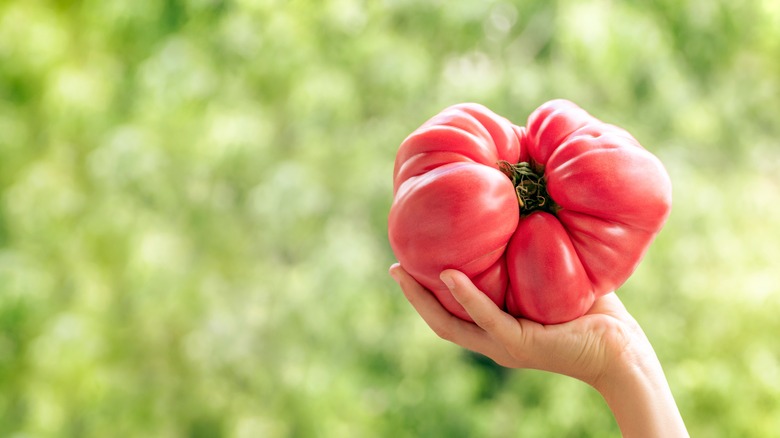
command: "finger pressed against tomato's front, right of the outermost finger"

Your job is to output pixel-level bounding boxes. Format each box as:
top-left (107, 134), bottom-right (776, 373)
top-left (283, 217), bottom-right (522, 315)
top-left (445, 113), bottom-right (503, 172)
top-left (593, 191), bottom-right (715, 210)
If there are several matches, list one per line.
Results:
top-left (441, 269), bottom-right (526, 346)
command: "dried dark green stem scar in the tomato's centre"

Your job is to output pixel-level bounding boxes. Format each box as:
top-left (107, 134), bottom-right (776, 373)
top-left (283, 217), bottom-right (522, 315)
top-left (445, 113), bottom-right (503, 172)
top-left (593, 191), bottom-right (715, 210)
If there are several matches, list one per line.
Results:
top-left (497, 160), bottom-right (560, 216)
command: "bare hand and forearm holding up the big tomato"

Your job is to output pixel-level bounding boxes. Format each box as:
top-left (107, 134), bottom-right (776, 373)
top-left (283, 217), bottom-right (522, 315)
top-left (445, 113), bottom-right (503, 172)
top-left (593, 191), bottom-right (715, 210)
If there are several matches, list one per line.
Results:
top-left (390, 263), bottom-right (688, 437)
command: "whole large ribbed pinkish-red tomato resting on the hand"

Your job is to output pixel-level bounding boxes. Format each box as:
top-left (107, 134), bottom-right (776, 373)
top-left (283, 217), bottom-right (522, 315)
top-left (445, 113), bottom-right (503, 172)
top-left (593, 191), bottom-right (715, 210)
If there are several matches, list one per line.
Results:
top-left (388, 100), bottom-right (671, 324)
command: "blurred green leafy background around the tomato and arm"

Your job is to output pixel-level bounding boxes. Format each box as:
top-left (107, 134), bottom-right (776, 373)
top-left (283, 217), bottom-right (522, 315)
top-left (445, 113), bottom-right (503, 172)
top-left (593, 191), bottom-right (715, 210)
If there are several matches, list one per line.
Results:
top-left (0, 0), bottom-right (780, 437)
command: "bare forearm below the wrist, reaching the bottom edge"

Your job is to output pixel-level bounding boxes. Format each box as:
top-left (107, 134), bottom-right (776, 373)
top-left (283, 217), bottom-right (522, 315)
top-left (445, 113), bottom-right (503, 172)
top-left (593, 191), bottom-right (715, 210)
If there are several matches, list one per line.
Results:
top-left (594, 354), bottom-right (688, 438)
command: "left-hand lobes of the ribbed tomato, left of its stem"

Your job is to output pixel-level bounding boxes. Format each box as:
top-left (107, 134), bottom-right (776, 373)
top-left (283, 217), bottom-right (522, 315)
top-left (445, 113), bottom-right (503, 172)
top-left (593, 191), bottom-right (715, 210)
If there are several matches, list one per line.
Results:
top-left (388, 104), bottom-right (522, 321)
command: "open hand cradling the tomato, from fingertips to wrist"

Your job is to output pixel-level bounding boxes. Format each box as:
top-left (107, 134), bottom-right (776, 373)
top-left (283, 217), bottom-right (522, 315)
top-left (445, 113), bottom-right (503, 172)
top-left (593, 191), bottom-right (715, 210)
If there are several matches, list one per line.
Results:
top-left (390, 264), bottom-right (649, 386)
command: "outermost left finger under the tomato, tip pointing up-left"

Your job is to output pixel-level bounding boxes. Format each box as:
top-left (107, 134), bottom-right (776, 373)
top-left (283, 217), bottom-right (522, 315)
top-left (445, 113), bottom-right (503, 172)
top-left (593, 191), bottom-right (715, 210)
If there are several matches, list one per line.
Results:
top-left (390, 263), bottom-right (511, 366)
